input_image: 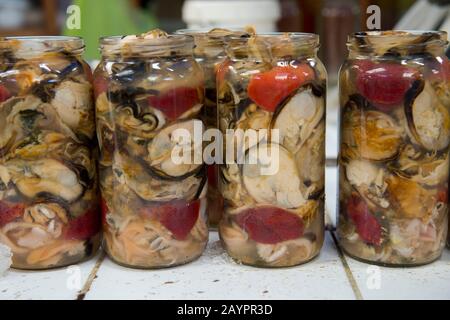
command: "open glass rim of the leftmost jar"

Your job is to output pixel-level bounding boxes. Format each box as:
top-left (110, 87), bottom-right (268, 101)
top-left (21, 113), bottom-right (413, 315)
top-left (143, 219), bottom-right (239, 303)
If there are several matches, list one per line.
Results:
top-left (0, 36), bottom-right (85, 53)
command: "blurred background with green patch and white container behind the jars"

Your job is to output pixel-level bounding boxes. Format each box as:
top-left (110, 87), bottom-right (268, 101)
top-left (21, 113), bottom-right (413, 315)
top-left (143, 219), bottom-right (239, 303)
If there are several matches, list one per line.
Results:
top-left (0, 0), bottom-right (450, 163)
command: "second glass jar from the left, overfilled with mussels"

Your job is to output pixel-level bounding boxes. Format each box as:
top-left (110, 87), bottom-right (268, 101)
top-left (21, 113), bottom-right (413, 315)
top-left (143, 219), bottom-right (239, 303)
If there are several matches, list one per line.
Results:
top-left (94, 30), bottom-right (208, 268)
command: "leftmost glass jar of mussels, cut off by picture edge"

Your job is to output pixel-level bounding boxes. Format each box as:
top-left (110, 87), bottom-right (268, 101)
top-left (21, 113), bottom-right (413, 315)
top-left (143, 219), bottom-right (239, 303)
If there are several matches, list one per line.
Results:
top-left (0, 37), bottom-right (100, 269)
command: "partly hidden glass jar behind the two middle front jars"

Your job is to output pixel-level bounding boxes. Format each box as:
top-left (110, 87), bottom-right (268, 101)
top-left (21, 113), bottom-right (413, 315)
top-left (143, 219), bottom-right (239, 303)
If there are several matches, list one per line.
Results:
top-left (177, 29), bottom-right (245, 229)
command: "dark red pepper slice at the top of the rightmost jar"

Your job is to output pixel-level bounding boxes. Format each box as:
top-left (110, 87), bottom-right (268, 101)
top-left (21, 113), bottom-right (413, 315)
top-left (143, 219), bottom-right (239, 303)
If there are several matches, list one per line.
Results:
top-left (355, 60), bottom-right (419, 112)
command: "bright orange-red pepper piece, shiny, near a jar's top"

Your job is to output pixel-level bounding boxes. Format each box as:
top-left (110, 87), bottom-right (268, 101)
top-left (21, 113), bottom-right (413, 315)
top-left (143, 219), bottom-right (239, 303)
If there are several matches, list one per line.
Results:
top-left (247, 64), bottom-right (314, 112)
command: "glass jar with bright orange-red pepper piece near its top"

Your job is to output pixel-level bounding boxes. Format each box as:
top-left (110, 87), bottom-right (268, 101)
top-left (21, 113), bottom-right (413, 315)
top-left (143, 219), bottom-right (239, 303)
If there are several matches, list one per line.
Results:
top-left (217, 33), bottom-right (326, 267)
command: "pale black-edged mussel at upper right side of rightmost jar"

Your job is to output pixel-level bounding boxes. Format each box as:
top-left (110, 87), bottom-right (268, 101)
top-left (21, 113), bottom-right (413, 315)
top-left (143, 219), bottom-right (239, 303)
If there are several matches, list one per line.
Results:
top-left (405, 80), bottom-right (450, 151)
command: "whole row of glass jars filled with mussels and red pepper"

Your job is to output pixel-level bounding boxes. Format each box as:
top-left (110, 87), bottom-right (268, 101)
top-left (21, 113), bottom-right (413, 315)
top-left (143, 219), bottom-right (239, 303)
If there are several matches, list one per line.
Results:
top-left (0, 29), bottom-right (450, 269)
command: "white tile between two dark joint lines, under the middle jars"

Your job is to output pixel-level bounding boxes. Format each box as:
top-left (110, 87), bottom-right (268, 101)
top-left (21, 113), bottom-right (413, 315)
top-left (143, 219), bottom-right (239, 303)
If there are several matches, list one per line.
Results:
top-left (86, 232), bottom-right (354, 300)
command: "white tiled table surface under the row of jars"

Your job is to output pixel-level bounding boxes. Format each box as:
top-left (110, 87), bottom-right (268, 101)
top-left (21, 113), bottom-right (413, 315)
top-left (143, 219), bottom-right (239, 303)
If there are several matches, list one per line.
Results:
top-left (0, 168), bottom-right (450, 300)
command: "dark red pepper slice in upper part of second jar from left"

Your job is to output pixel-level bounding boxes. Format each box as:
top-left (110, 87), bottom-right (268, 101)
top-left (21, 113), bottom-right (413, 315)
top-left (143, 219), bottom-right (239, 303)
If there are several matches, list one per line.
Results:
top-left (148, 87), bottom-right (200, 120)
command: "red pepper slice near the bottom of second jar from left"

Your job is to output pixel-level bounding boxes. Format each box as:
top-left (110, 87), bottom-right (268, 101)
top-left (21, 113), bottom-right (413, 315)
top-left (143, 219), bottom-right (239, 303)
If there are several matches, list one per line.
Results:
top-left (141, 200), bottom-right (200, 241)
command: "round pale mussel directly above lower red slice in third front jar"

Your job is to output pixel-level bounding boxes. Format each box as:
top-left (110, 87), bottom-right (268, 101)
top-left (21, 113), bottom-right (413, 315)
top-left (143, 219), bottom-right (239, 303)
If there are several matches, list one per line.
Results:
top-left (242, 144), bottom-right (305, 209)
